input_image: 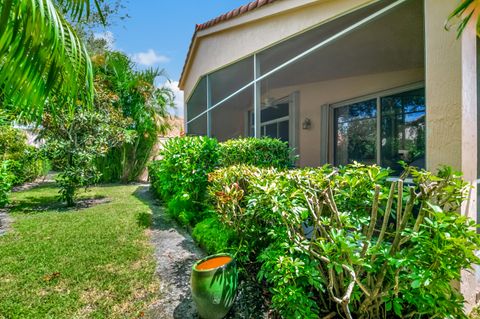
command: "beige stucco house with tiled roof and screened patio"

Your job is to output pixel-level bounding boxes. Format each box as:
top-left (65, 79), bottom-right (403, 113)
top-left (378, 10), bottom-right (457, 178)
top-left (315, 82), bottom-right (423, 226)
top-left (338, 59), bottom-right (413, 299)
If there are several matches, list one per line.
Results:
top-left (180, 0), bottom-right (480, 305)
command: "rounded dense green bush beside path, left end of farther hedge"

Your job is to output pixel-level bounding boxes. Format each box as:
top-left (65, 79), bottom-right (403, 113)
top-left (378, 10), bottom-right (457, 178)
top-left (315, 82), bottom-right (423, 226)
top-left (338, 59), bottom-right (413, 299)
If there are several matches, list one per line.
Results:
top-left (149, 137), bottom-right (219, 225)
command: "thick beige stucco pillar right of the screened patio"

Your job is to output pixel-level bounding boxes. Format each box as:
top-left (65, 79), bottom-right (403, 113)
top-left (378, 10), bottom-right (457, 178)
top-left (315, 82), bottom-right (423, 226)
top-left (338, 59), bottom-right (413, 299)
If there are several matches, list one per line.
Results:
top-left (425, 0), bottom-right (480, 311)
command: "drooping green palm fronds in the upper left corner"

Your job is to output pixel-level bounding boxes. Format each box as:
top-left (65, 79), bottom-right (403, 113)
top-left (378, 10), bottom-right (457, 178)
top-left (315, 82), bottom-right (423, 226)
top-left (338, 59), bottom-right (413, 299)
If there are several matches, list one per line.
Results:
top-left (0, 0), bottom-right (101, 118)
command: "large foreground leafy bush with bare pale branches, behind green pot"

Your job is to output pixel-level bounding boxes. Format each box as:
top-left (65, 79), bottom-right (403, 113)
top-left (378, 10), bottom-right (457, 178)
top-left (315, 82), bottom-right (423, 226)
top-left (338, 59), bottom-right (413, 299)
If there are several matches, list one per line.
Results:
top-left (209, 164), bottom-right (480, 318)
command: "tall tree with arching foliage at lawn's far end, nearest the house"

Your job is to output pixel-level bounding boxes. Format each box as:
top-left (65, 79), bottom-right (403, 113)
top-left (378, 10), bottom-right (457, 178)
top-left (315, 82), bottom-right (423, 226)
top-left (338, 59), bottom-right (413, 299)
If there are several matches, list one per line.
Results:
top-left (92, 50), bottom-right (174, 182)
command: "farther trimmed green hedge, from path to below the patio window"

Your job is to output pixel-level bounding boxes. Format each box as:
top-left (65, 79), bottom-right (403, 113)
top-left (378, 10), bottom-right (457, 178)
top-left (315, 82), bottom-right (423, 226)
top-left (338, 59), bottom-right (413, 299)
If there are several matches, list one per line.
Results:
top-left (149, 136), bottom-right (293, 226)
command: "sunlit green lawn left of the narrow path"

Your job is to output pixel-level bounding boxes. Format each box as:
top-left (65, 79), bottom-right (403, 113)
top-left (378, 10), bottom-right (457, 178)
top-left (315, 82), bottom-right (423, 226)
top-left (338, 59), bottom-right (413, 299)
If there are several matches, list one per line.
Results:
top-left (0, 185), bottom-right (158, 318)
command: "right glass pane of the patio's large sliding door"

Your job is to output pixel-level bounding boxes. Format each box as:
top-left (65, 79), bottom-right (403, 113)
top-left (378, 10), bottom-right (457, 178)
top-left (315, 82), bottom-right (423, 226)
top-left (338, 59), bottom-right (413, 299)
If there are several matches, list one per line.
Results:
top-left (381, 89), bottom-right (425, 172)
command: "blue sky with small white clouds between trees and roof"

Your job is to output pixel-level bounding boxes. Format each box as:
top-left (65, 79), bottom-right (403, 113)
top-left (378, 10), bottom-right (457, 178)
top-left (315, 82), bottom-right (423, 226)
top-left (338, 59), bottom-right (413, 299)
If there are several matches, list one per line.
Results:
top-left (98, 0), bottom-right (248, 115)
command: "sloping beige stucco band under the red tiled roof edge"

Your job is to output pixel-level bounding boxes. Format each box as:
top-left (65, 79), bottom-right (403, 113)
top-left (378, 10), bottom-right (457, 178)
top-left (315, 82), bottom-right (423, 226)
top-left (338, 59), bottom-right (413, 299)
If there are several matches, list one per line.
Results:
top-left (180, 0), bottom-right (376, 100)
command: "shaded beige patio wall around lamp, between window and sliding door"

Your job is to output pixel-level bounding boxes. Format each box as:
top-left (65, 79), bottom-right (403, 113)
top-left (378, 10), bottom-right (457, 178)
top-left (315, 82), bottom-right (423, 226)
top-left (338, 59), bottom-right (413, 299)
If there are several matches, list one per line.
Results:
top-left (268, 69), bottom-right (424, 166)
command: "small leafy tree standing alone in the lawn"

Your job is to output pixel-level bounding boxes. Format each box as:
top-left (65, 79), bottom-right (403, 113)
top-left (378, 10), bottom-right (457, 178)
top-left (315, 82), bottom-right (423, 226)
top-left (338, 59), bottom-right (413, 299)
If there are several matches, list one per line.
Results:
top-left (42, 104), bottom-right (134, 206)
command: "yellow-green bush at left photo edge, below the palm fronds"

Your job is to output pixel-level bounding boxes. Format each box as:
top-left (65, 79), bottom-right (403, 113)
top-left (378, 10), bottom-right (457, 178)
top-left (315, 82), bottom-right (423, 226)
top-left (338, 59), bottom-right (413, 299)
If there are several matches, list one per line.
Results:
top-left (0, 125), bottom-right (49, 185)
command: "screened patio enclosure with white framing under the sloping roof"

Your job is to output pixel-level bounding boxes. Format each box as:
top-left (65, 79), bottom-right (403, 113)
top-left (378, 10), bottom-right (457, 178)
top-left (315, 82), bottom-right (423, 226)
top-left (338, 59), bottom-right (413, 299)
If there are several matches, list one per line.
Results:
top-left (186, 0), bottom-right (426, 170)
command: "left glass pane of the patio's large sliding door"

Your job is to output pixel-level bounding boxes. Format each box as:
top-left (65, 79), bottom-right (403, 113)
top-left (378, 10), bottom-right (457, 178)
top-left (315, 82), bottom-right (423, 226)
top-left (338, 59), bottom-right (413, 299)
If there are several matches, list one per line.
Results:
top-left (334, 99), bottom-right (377, 165)
